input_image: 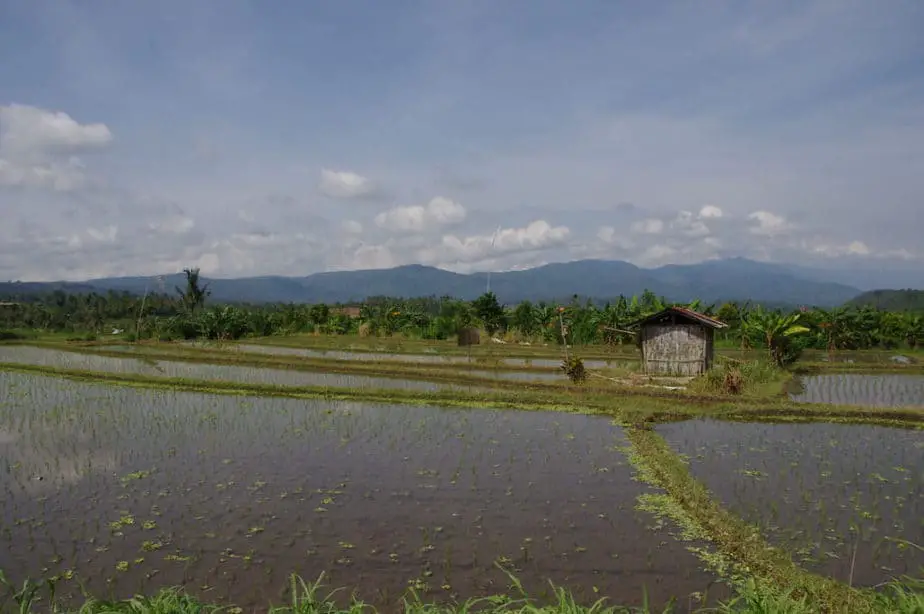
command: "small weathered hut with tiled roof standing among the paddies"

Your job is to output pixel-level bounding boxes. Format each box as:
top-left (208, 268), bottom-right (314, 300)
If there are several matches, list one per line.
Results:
top-left (635, 307), bottom-right (728, 376)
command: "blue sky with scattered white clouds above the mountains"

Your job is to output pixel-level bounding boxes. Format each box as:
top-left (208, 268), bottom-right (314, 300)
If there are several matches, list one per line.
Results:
top-left (0, 0), bottom-right (924, 281)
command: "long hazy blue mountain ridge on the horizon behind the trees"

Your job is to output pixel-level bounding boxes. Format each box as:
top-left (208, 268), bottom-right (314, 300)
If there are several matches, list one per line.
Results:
top-left (0, 258), bottom-right (861, 306)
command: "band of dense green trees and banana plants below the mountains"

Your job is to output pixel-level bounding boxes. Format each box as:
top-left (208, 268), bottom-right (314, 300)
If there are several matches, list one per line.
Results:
top-left (0, 269), bottom-right (924, 363)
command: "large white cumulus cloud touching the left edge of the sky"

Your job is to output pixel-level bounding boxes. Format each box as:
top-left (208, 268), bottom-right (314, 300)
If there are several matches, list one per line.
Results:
top-left (0, 104), bottom-right (112, 192)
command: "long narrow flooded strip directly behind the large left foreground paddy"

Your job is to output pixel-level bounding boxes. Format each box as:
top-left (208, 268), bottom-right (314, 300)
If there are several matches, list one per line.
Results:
top-left (0, 346), bottom-right (474, 391)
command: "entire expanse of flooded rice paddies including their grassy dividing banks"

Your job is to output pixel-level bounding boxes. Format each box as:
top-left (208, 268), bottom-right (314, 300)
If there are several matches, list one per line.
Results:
top-left (0, 344), bottom-right (924, 612)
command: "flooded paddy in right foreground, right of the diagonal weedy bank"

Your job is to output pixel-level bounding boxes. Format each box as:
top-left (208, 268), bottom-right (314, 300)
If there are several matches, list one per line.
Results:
top-left (657, 420), bottom-right (924, 586)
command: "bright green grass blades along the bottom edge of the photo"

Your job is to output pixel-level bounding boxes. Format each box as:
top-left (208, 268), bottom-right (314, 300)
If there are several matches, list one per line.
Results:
top-left (0, 572), bottom-right (924, 614)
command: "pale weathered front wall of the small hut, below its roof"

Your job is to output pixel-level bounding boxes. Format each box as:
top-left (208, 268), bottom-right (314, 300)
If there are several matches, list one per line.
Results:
top-left (641, 324), bottom-right (712, 376)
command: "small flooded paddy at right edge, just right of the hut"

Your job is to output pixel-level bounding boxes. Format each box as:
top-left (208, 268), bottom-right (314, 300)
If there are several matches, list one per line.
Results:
top-left (790, 373), bottom-right (924, 407)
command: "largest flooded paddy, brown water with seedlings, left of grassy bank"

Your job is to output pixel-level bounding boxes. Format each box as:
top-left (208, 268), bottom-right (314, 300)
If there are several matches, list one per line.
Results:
top-left (0, 373), bottom-right (727, 611)
